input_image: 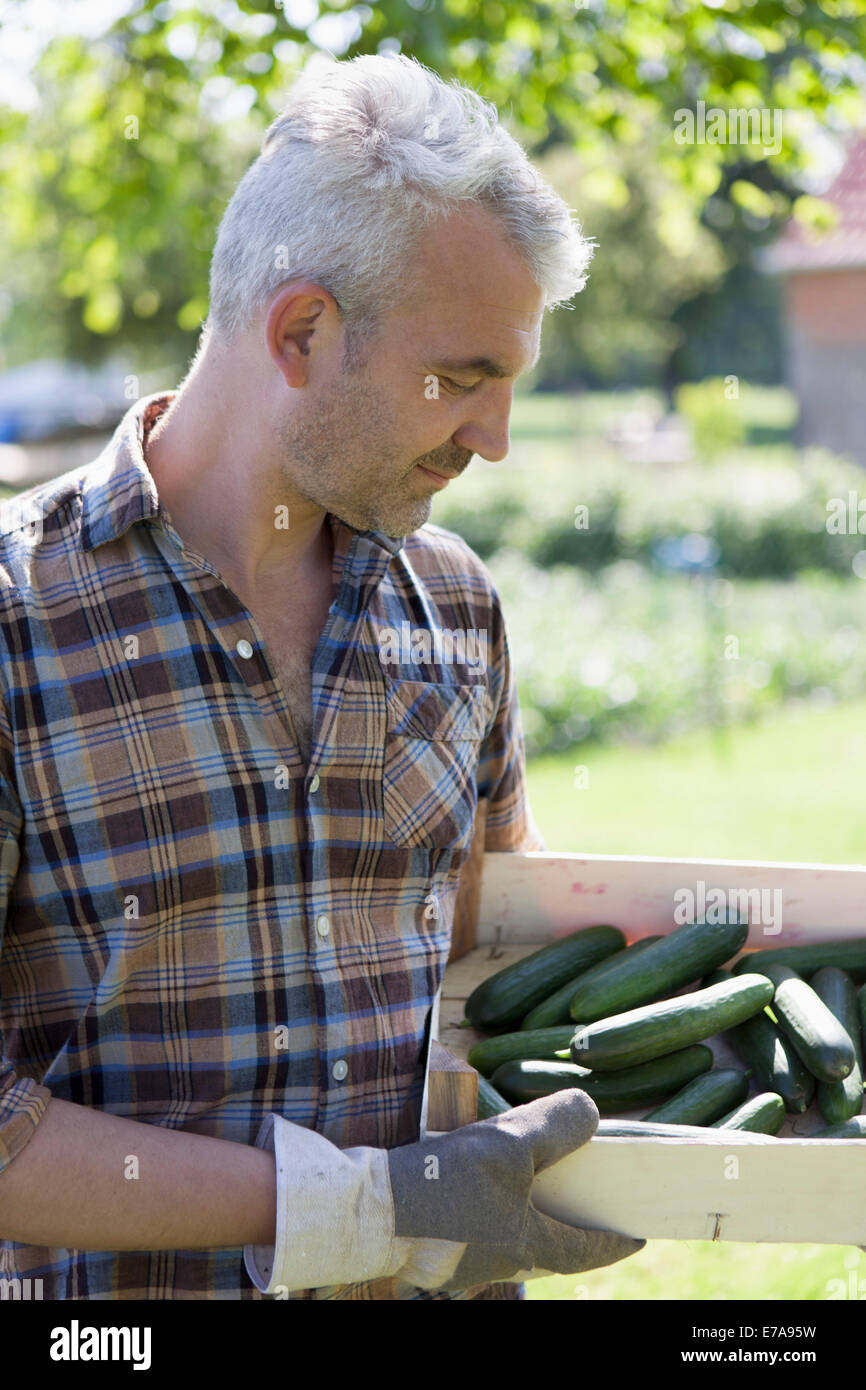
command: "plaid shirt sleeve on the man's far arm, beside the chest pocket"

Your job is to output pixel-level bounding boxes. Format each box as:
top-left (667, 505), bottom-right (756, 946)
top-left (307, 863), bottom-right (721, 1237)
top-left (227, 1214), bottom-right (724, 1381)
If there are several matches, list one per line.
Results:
top-left (477, 588), bottom-right (546, 852)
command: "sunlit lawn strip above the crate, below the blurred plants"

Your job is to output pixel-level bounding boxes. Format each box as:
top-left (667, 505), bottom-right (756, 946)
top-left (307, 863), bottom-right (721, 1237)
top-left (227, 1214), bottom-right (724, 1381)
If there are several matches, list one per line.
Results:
top-left (527, 701), bottom-right (866, 863)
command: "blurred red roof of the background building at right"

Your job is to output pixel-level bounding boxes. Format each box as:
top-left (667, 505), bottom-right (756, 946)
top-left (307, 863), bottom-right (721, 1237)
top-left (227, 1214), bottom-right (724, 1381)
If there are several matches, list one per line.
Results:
top-left (763, 133), bottom-right (866, 274)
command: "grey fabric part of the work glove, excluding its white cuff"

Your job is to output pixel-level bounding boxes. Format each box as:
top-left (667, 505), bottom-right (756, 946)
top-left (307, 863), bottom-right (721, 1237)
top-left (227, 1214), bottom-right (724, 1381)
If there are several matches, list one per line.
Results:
top-left (388, 1090), bottom-right (646, 1293)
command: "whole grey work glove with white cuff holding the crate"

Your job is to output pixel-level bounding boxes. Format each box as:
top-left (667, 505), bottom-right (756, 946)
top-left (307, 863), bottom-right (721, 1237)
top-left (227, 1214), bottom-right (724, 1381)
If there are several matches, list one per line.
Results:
top-left (245, 1090), bottom-right (646, 1294)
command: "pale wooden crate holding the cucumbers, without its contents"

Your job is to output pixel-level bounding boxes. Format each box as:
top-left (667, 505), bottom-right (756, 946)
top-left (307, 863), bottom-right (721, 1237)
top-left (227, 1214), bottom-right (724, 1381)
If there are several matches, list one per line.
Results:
top-left (436, 853), bottom-right (866, 1245)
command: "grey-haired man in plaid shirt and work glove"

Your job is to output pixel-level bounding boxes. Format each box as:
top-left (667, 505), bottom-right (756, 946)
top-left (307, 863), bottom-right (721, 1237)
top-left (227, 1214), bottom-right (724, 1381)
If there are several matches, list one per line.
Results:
top-left (0, 58), bottom-right (641, 1298)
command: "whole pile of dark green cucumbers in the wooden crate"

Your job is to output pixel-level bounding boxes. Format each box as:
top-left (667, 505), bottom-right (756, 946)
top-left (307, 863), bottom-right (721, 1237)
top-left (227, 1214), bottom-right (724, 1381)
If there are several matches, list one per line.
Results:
top-left (466, 919), bottom-right (866, 1138)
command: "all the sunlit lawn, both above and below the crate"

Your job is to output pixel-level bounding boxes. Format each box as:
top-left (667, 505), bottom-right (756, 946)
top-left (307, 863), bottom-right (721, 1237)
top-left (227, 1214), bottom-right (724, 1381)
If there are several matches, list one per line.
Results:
top-left (527, 701), bottom-right (866, 1300)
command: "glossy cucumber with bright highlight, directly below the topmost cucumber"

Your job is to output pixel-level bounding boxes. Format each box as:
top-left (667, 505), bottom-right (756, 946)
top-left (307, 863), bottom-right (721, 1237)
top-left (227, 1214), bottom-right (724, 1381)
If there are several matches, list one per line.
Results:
top-left (571, 973), bottom-right (773, 1072)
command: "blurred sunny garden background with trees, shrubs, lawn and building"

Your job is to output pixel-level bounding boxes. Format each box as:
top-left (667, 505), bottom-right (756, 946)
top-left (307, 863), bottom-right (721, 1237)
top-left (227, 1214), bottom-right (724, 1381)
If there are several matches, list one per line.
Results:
top-left (0, 0), bottom-right (866, 1300)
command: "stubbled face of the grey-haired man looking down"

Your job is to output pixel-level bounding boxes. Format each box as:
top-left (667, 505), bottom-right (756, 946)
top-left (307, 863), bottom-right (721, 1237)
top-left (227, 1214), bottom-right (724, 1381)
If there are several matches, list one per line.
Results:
top-left (273, 209), bottom-right (544, 537)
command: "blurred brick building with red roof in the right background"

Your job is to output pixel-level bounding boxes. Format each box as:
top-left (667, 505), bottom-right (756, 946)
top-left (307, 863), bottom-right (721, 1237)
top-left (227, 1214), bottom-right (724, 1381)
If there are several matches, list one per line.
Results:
top-left (762, 135), bottom-right (866, 467)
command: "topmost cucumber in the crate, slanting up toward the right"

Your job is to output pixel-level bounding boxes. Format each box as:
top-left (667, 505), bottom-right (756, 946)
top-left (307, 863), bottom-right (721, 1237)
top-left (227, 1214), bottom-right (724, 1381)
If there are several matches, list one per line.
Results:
top-left (570, 922), bottom-right (749, 1023)
